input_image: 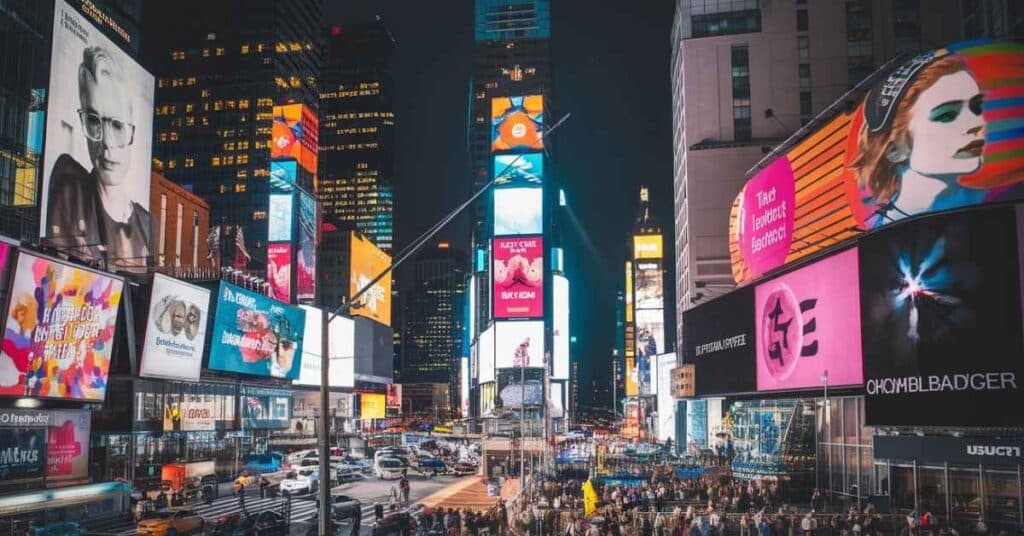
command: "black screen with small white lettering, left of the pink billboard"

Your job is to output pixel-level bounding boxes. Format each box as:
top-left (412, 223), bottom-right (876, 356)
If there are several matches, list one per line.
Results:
top-left (680, 286), bottom-right (757, 397)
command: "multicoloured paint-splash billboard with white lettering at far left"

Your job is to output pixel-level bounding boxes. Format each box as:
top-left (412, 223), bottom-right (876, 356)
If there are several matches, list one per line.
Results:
top-left (0, 251), bottom-right (123, 401)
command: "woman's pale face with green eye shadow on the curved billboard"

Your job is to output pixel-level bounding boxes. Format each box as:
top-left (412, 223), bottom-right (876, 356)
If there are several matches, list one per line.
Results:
top-left (908, 71), bottom-right (985, 176)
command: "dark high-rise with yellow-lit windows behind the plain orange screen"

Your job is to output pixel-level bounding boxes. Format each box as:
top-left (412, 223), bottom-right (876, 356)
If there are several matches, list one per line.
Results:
top-left (316, 18), bottom-right (395, 253)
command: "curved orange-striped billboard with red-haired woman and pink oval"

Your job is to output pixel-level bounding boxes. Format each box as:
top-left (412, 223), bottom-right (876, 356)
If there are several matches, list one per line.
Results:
top-left (729, 40), bottom-right (1024, 283)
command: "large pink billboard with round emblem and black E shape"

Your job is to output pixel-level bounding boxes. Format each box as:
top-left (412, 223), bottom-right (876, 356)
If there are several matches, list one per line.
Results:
top-left (754, 248), bottom-right (863, 390)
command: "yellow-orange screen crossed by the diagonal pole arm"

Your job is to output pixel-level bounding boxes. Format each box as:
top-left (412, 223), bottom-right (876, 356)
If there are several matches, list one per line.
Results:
top-left (348, 233), bottom-right (391, 326)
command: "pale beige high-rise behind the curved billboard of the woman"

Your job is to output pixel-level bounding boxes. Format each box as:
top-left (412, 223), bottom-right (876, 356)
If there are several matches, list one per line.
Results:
top-left (672, 0), bottom-right (966, 344)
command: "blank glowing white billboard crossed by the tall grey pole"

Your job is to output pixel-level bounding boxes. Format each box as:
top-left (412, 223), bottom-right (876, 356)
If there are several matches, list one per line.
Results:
top-left (293, 305), bottom-right (355, 387)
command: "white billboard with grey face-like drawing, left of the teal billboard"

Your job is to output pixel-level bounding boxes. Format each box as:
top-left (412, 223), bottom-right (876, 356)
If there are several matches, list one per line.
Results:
top-left (139, 274), bottom-right (210, 381)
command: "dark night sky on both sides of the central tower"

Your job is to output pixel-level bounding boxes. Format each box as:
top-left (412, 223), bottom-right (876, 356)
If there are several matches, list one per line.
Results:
top-left (327, 0), bottom-right (675, 411)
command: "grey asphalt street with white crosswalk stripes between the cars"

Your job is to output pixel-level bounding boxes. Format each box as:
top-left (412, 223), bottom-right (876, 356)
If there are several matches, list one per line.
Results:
top-left (88, 472), bottom-right (475, 536)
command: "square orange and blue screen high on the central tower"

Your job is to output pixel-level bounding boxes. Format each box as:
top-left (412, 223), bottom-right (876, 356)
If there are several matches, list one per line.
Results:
top-left (490, 95), bottom-right (544, 152)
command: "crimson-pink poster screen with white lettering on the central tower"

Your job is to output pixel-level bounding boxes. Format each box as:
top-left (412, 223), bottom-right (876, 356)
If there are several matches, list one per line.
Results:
top-left (494, 237), bottom-right (544, 319)
